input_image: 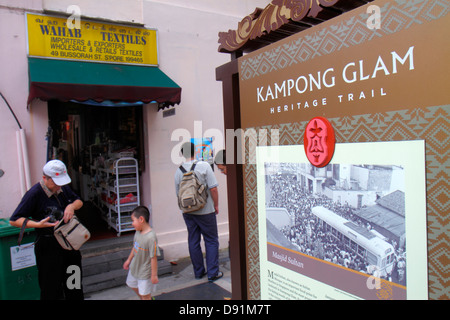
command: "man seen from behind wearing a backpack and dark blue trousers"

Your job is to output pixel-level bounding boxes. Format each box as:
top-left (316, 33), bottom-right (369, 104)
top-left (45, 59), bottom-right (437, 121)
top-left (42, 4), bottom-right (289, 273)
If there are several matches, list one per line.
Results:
top-left (175, 142), bottom-right (223, 282)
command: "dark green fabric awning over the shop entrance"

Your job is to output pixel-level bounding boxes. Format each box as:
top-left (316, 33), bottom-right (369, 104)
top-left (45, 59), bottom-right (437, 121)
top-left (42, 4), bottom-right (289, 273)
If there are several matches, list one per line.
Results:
top-left (28, 58), bottom-right (181, 105)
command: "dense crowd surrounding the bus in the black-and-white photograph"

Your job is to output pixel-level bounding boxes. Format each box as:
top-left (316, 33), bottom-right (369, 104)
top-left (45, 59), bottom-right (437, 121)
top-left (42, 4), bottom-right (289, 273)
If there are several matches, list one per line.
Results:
top-left (267, 173), bottom-right (406, 285)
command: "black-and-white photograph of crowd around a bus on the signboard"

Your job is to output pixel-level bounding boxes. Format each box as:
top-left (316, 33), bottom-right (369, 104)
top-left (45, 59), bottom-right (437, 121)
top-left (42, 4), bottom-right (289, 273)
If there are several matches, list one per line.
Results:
top-left (265, 162), bottom-right (406, 286)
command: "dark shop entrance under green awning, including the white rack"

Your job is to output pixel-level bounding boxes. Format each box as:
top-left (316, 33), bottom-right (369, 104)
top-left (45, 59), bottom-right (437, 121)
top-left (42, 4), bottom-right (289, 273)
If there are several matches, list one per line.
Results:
top-left (47, 100), bottom-right (145, 238)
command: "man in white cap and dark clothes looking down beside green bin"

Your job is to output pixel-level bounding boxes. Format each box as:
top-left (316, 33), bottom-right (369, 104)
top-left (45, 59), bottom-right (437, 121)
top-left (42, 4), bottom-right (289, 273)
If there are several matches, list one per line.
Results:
top-left (10, 160), bottom-right (84, 300)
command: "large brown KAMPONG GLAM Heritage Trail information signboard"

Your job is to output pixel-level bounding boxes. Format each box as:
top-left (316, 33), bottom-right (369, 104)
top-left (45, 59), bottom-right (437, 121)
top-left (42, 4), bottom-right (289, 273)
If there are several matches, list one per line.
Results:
top-left (239, 0), bottom-right (450, 299)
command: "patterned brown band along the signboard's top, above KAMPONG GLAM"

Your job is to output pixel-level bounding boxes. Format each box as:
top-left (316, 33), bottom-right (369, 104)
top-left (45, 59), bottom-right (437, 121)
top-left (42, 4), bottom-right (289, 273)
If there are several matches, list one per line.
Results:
top-left (240, 0), bottom-right (450, 81)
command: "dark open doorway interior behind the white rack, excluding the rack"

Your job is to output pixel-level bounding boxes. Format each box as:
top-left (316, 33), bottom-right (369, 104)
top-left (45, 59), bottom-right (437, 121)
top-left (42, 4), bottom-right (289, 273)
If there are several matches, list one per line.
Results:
top-left (47, 100), bottom-right (145, 238)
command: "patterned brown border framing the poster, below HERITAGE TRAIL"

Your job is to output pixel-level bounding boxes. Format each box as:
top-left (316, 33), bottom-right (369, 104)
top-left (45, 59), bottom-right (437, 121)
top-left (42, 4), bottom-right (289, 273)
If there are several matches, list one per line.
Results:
top-left (244, 105), bottom-right (450, 300)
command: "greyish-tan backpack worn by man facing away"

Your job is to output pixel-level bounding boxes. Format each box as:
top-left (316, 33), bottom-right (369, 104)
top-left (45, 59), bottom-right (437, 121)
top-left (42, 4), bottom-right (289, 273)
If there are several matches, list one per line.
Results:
top-left (178, 162), bottom-right (208, 213)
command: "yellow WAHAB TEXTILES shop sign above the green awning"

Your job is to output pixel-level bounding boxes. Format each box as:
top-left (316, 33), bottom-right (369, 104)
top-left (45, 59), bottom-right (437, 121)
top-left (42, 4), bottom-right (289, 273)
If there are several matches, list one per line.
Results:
top-left (26, 14), bottom-right (158, 66)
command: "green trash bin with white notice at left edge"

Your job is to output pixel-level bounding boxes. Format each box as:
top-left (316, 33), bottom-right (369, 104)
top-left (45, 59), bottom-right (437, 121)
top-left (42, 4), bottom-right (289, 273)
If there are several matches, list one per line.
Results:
top-left (0, 219), bottom-right (41, 300)
